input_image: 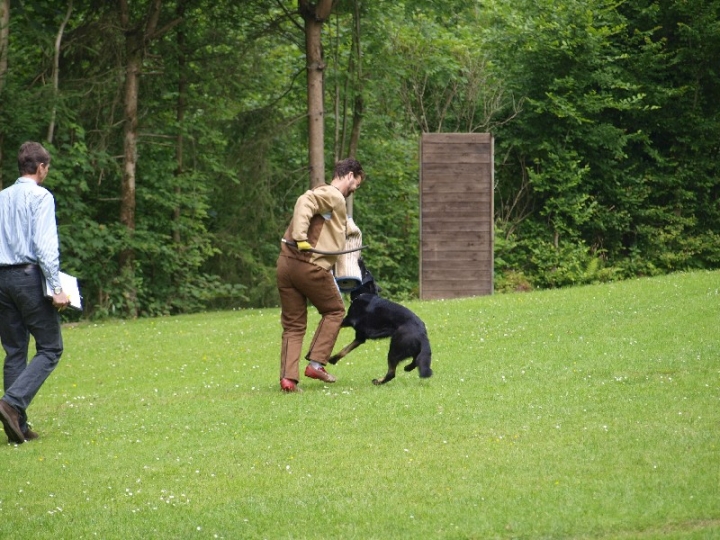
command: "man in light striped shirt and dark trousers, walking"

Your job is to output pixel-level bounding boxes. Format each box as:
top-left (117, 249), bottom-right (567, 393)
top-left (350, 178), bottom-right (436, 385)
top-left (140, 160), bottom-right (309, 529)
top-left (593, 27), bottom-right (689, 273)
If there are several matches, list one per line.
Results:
top-left (0, 142), bottom-right (70, 444)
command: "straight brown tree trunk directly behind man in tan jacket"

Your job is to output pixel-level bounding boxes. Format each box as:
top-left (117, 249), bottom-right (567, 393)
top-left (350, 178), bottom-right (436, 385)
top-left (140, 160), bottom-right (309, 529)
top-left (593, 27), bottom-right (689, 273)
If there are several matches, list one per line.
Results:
top-left (298, 0), bottom-right (333, 187)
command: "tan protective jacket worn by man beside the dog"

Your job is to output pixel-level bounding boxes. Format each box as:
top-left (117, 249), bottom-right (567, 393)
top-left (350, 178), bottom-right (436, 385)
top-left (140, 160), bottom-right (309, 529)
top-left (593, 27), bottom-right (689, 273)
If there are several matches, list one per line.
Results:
top-left (280, 184), bottom-right (347, 270)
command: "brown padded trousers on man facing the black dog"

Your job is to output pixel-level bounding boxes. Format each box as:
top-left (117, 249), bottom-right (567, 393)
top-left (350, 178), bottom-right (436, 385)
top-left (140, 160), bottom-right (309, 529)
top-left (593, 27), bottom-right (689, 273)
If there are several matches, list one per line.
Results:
top-left (277, 255), bottom-right (345, 381)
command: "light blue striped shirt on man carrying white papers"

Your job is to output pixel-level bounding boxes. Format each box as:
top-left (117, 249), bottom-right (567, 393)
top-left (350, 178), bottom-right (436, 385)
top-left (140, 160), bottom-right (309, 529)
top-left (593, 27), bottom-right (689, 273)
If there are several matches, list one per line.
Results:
top-left (0, 177), bottom-right (60, 287)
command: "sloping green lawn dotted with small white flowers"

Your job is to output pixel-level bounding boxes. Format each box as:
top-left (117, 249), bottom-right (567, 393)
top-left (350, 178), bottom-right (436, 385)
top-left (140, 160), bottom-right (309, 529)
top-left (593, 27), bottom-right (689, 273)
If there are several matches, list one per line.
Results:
top-left (0, 272), bottom-right (720, 540)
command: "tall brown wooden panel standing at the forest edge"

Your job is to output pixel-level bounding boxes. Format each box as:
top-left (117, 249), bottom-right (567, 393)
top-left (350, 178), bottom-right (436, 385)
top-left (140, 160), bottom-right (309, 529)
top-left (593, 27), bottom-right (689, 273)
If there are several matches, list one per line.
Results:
top-left (420, 133), bottom-right (494, 300)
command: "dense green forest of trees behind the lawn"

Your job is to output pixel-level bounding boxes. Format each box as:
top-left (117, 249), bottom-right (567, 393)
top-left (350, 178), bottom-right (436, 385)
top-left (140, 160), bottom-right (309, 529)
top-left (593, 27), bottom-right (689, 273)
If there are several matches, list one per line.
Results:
top-left (0, 0), bottom-right (720, 317)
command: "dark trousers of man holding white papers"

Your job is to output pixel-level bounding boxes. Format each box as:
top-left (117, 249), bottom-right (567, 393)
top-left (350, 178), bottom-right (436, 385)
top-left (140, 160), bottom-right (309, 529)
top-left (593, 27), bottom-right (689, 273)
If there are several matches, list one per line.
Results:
top-left (0, 265), bottom-right (63, 431)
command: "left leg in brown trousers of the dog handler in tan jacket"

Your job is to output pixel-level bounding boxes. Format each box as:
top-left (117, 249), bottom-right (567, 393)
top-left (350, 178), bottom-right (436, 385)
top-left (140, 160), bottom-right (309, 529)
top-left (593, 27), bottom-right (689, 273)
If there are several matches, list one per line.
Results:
top-left (277, 257), bottom-right (307, 382)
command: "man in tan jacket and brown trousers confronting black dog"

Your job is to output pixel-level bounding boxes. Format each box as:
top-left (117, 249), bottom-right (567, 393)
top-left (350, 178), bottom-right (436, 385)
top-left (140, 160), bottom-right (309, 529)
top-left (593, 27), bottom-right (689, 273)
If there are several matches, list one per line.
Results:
top-left (277, 159), bottom-right (365, 392)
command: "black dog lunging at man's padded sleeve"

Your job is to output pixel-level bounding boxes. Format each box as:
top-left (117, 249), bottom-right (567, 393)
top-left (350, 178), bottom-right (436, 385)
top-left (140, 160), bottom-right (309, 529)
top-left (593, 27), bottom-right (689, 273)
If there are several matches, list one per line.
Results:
top-left (329, 259), bottom-right (432, 384)
